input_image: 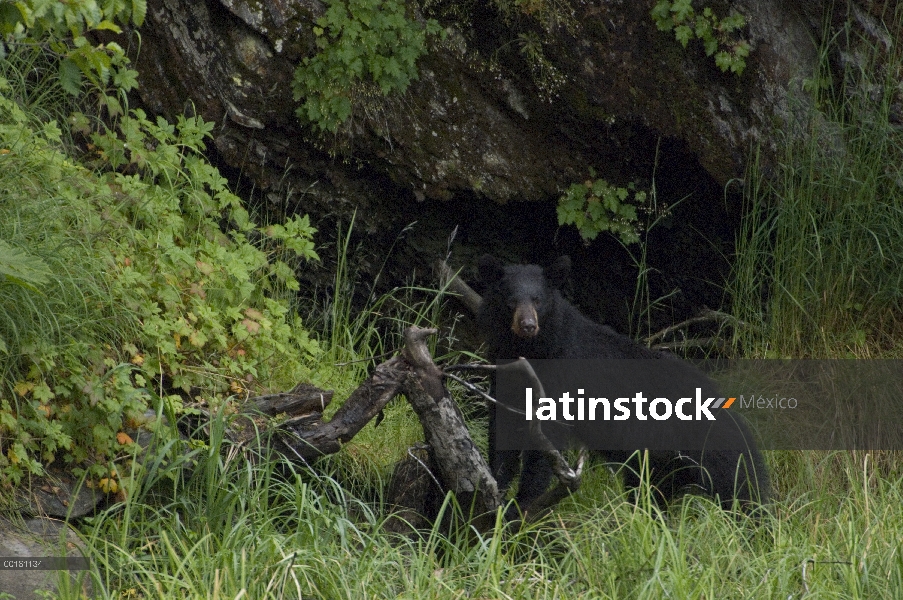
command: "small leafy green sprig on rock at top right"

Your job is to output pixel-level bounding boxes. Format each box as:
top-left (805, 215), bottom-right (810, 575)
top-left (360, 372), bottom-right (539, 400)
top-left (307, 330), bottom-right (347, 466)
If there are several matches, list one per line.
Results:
top-left (652, 0), bottom-right (752, 75)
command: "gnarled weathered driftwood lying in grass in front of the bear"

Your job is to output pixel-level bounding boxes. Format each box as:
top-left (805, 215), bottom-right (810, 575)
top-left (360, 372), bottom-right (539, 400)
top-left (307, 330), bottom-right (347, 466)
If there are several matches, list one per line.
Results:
top-left (233, 327), bottom-right (580, 529)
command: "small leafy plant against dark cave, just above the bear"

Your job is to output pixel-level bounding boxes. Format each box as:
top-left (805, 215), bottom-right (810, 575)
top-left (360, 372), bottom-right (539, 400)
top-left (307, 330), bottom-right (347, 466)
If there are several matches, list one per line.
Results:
top-left (557, 171), bottom-right (646, 244)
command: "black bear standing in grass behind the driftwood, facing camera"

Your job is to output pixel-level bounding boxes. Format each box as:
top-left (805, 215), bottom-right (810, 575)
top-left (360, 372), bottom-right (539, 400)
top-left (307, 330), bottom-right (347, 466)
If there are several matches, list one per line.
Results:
top-left (477, 255), bottom-right (769, 510)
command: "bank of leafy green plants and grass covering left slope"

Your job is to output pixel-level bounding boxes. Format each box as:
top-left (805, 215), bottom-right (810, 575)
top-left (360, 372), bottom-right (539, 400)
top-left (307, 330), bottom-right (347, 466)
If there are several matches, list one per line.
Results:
top-left (0, 65), bottom-right (318, 490)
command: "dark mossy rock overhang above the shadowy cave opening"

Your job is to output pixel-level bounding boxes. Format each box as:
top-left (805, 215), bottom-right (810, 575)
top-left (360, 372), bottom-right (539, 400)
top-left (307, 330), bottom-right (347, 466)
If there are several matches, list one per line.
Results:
top-left (137, 0), bottom-right (825, 214)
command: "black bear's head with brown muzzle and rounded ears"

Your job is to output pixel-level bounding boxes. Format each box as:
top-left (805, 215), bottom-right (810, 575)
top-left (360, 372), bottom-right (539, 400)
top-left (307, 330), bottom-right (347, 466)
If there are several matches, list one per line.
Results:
top-left (478, 254), bottom-right (571, 339)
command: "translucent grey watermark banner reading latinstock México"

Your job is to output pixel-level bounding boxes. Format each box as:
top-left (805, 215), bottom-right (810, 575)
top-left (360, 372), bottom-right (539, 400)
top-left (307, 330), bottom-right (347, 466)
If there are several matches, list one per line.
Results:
top-left (495, 358), bottom-right (903, 451)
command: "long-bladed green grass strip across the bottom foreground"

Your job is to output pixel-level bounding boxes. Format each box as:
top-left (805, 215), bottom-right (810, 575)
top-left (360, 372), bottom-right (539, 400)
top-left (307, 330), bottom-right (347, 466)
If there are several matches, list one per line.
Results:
top-left (54, 422), bottom-right (903, 599)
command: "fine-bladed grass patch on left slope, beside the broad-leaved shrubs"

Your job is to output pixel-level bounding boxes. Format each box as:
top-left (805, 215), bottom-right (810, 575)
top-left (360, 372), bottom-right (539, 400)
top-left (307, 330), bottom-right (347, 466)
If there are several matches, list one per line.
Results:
top-left (0, 141), bottom-right (136, 382)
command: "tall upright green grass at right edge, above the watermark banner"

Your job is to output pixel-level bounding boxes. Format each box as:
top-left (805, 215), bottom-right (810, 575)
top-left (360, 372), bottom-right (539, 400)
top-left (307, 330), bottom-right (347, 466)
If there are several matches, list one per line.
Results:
top-left (729, 8), bottom-right (903, 357)
